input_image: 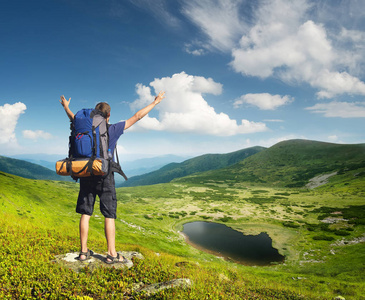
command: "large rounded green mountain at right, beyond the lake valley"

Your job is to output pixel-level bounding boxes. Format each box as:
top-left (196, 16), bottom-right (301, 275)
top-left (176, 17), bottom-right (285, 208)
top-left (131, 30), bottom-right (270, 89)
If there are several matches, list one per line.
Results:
top-left (176, 140), bottom-right (365, 187)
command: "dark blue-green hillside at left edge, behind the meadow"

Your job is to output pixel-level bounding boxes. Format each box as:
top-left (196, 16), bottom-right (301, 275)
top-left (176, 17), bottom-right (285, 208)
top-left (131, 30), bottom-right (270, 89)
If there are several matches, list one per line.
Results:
top-left (0, 156), bottom-right (72, 181)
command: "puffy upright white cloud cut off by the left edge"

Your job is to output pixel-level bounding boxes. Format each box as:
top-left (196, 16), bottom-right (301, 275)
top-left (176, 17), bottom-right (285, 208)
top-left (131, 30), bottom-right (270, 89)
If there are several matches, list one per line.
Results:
top-left (0, 102), bottom-right (27, 146)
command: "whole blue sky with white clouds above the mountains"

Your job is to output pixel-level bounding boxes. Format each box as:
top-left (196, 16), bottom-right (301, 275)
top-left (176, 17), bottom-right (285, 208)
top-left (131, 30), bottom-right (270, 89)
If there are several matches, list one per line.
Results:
top-left (0, 0), bottom-right (365, 160)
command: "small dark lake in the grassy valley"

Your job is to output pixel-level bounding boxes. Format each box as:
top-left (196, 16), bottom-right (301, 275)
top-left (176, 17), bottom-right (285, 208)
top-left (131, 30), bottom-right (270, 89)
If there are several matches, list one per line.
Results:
top-left (182, 221), bottom-right (285, 266)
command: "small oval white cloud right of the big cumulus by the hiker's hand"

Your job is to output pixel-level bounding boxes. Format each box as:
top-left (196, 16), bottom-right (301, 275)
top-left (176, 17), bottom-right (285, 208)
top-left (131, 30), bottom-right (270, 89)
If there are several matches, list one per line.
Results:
top-left (233, 93), bottom-right (294, 110)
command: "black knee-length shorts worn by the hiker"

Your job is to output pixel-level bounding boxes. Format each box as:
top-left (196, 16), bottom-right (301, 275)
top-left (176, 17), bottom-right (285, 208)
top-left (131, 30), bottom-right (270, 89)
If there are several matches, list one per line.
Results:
top-left (76, 173), bottom-right (117, 219)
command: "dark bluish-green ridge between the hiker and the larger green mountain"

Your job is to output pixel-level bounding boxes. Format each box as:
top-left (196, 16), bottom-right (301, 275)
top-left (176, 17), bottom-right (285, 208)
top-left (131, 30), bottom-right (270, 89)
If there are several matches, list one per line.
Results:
top-left (122, 146), bottom-right (265, 187)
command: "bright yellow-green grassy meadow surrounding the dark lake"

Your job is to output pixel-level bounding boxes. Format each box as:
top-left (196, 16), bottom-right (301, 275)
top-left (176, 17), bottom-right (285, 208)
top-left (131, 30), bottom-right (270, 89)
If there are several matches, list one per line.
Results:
top-left (0, 170), bottom-right (365, 299)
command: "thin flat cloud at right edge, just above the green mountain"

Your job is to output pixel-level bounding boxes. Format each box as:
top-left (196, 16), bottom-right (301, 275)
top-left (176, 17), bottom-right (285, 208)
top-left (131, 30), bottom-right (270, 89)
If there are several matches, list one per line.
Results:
top-left (306, 101), bottom-right (365, 118)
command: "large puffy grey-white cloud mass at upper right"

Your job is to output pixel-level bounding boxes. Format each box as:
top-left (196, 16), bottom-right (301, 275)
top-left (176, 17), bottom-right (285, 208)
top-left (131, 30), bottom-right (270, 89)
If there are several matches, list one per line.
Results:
top-left (231, 6), bottom-right (365, 98)
